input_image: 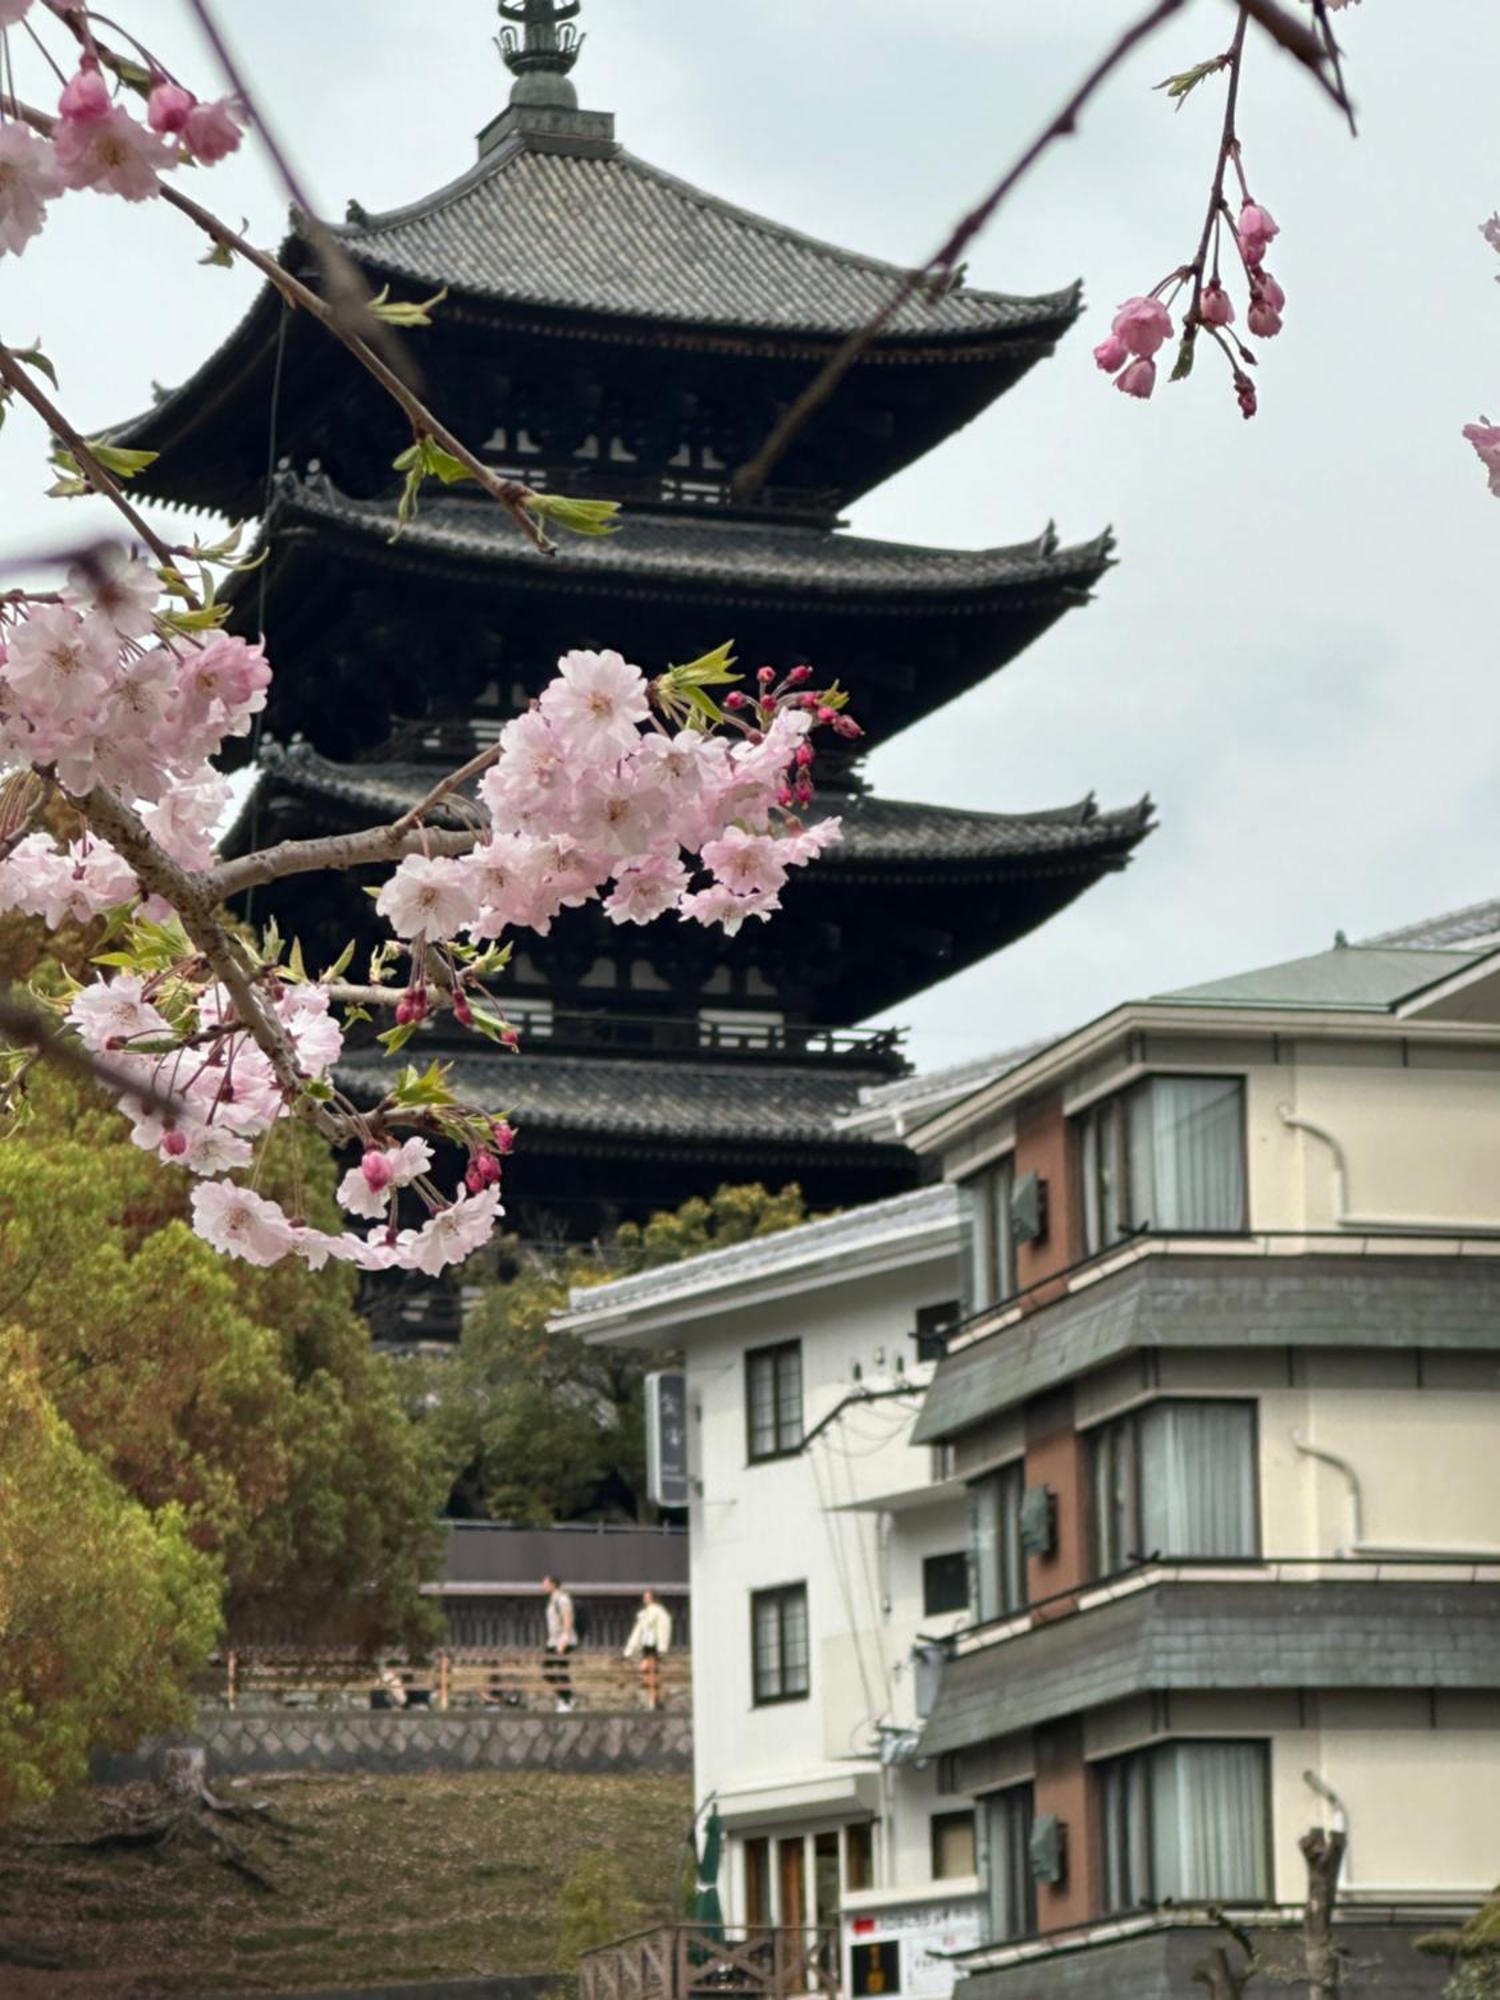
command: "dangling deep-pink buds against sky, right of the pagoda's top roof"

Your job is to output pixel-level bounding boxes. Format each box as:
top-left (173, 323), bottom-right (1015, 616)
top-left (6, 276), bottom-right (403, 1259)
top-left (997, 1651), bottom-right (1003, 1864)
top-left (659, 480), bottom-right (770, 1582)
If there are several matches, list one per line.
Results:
top-left (1094, 194), bottom-right (1286, 416)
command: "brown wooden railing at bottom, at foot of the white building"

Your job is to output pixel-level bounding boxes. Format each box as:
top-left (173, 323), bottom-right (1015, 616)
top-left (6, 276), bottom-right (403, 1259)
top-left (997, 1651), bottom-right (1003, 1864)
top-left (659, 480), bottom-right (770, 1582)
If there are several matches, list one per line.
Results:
top-left (578, 1924), bottom-right (838, 2000)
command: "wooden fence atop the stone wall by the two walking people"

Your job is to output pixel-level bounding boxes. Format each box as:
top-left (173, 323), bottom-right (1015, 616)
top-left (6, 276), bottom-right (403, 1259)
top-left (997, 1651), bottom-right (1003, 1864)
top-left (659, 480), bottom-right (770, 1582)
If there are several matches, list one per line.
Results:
top-left (200, 1646), bottom-right (692, 1712)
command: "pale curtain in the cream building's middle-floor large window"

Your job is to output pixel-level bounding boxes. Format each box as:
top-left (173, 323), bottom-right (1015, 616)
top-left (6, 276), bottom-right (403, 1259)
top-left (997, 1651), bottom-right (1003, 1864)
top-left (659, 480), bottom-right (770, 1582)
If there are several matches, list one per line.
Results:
top-left (1140, 1402), bottom-right (1258, 1556)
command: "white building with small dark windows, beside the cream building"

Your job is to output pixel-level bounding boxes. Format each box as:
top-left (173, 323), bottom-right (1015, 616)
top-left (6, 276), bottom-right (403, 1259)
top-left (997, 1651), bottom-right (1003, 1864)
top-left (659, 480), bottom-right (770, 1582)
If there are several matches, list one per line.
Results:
top-left (562, 1186), bottom-right (1000, 1994)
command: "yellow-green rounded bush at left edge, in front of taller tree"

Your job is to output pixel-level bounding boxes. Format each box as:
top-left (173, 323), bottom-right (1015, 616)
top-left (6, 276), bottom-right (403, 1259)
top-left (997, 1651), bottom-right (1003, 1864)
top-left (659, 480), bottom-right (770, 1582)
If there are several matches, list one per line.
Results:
top-left (0, 1354), bottom-right (222, 1816)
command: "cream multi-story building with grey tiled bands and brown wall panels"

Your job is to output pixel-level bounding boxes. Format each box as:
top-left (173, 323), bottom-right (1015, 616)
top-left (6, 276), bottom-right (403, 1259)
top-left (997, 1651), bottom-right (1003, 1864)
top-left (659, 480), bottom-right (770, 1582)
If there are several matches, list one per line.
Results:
top-left (902, 926), bottom-right (1500, 2000)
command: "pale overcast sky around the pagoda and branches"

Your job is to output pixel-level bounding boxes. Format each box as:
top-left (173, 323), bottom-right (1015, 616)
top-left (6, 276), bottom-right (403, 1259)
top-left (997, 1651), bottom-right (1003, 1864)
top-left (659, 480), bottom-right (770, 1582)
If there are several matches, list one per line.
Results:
top-left (0, 0), bottom-right (1500, 1066)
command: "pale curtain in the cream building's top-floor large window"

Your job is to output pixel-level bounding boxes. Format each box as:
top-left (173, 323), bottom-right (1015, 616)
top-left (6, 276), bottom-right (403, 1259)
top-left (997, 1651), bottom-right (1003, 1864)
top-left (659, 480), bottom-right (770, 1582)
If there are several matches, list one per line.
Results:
top-left (1128, 1076), bottom-right (1244, 1230)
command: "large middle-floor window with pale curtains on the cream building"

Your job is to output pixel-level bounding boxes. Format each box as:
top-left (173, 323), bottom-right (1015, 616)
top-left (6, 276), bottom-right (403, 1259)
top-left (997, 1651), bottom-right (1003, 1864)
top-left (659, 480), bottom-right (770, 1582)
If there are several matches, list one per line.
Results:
top-left (1088, 1402), bottom-right (1260, 1576)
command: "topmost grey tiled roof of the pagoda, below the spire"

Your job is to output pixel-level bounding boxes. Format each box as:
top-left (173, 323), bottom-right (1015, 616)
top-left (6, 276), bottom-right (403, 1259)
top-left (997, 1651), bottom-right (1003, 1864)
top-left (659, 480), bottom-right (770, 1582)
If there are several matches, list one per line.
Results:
top-left (334, 146), bottom-right (1078, 344)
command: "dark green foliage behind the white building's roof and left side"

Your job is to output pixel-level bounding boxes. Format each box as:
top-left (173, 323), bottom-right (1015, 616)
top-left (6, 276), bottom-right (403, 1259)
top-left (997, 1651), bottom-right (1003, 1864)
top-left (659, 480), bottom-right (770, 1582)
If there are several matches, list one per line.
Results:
top-left (434, 1186), bottom-right (808, 1524)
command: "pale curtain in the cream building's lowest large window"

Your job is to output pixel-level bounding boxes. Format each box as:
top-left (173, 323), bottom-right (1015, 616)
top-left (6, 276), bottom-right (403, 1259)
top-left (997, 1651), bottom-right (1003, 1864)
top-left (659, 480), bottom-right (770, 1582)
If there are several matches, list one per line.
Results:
top-left (1152, 1744), bottom-right (1270, 1902)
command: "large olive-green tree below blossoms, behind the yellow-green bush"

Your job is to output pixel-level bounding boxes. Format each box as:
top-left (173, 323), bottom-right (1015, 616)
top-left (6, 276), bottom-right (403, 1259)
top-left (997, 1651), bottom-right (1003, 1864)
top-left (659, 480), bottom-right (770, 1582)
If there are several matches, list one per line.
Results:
top-left (0, 1076), bottom-right (446, 1646)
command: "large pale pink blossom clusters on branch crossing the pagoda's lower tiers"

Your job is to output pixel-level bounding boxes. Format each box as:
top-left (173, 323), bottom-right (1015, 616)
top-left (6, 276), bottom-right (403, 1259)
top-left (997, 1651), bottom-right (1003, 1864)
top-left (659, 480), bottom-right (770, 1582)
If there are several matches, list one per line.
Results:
top-left (0, 548), bottom-right (858, 1274)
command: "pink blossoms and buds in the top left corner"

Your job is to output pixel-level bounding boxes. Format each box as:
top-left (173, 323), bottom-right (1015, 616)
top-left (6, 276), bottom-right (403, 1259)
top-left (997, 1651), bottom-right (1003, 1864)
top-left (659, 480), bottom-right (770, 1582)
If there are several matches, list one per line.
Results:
top-left (0, 0), bottom-right (244, 256)
